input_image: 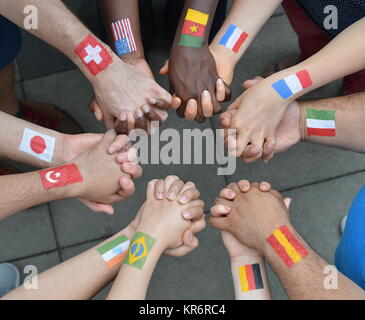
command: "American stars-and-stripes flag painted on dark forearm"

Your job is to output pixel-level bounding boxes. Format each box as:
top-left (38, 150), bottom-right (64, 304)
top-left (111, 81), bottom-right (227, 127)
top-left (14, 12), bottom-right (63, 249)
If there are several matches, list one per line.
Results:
top-left (112, 18), bottom-right (137, 56)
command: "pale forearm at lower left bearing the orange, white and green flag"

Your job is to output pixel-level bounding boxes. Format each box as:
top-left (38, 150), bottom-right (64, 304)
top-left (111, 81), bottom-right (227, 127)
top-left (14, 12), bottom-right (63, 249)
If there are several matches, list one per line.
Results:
top-left (4, 226), bottom-right (134, 300)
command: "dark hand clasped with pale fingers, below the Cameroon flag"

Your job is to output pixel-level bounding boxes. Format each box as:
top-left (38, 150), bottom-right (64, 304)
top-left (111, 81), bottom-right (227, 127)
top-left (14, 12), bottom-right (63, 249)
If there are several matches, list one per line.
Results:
top-left (160, 46), bottom-right (230, 122)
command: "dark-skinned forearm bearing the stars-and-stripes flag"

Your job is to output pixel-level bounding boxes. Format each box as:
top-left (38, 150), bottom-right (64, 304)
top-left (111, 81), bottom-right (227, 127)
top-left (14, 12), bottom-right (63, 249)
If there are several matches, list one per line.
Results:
top-left (98, 0), bottom-right (144, 62)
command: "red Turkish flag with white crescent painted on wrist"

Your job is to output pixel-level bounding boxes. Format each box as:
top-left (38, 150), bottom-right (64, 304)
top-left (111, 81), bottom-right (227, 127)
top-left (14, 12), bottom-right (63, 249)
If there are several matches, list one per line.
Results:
top-left (39, 163), bottom-right (84, 189)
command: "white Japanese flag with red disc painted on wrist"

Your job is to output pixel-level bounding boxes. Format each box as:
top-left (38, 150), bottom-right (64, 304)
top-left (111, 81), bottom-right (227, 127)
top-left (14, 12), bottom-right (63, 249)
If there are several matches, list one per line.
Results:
top-left (19, 128), bottom-right (56, 163)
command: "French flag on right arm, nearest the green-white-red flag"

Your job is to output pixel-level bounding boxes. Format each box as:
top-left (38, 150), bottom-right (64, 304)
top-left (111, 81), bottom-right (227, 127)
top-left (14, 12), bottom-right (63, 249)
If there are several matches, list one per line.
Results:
top-left (272, 70), bottom-right (312, 99)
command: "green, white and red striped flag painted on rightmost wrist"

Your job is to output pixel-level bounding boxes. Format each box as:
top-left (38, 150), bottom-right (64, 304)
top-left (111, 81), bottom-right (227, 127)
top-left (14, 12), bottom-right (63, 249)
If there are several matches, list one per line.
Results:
top-left (305, 108), bottom-right (336, 137)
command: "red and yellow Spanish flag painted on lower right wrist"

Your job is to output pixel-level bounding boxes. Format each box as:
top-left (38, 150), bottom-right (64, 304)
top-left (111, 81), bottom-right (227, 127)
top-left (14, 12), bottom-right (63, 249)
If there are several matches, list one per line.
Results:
top-left (266, 226), bottom-right (308, 267)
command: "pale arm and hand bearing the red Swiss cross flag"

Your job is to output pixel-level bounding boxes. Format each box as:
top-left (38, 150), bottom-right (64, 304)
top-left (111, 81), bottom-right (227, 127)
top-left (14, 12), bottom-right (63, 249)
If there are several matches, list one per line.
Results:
top-left (0, 0), bottom-right (171, 129)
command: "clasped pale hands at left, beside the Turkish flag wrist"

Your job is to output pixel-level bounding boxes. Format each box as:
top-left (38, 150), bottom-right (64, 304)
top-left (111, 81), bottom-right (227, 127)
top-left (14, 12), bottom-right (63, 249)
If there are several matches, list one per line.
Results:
top-left (71, 130), bottom-right (142, 213)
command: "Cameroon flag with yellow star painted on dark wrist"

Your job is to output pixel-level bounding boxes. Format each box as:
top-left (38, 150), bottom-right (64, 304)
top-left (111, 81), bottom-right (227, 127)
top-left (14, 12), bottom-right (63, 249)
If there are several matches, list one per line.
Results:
top-left (179, 9), bottom-right (209, 48)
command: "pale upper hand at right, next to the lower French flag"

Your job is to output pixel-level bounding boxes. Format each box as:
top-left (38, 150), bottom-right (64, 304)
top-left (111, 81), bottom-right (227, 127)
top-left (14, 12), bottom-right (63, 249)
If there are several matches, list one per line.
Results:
top-left (220, 75), bottom-right (291, 162)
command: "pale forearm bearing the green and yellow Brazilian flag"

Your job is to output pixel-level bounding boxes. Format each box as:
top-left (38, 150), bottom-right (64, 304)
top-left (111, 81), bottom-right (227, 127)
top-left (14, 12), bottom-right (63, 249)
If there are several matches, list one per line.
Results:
top-left (107, 230), bottom-right (164, 300)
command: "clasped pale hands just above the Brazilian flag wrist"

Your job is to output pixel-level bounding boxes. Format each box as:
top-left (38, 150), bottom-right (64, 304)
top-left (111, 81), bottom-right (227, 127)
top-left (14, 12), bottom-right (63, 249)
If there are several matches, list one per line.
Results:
top-left (134, 176), bottom-right (205, 252)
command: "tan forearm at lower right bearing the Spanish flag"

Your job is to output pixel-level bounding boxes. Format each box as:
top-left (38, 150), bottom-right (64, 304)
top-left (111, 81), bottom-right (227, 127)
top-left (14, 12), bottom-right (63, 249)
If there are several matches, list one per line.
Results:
top-left (263, 226), bottom-right (365, 300)
